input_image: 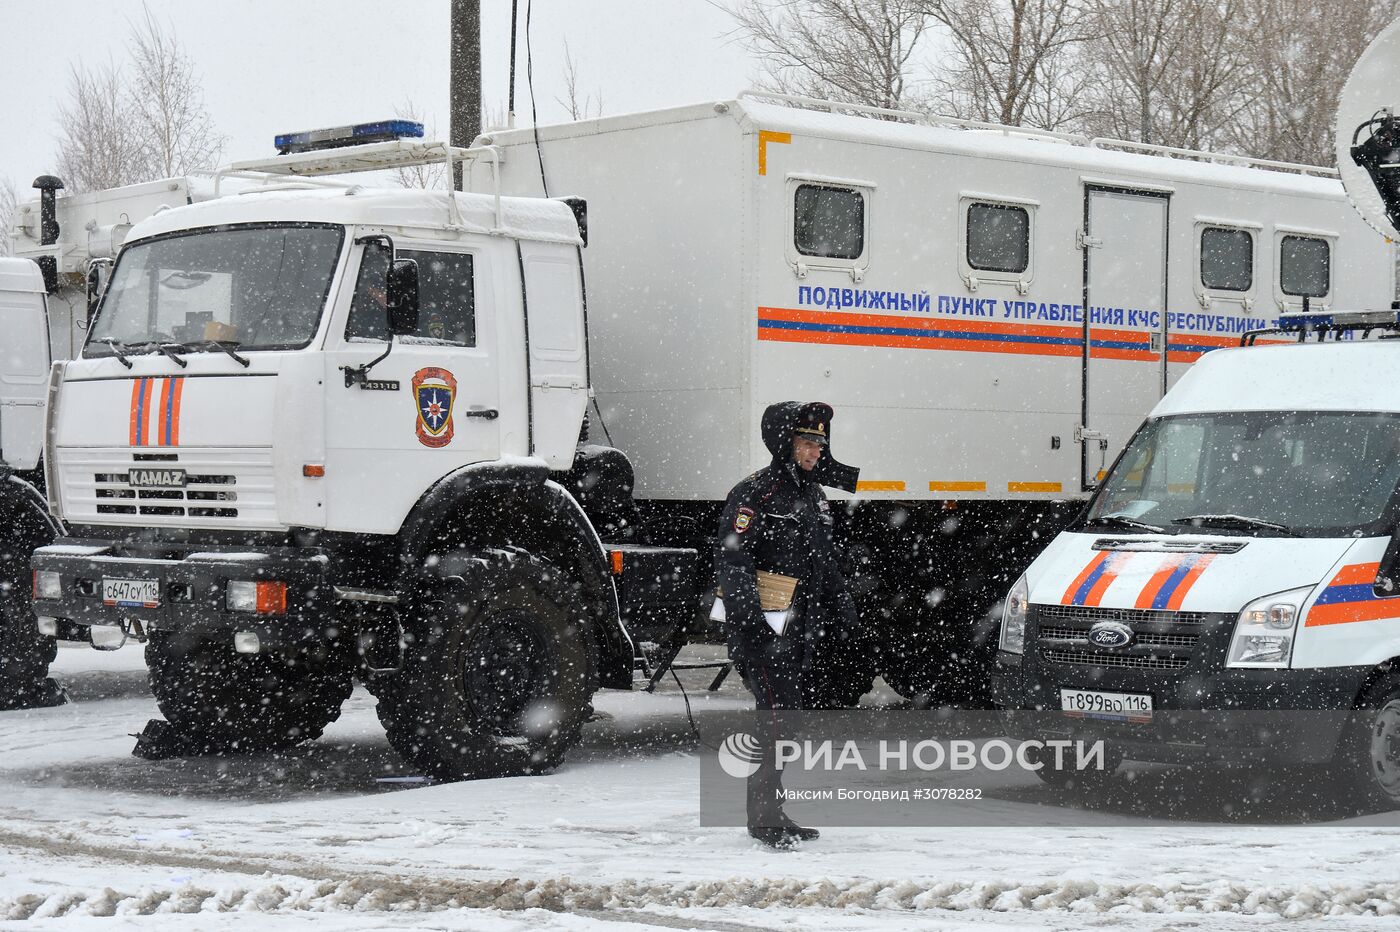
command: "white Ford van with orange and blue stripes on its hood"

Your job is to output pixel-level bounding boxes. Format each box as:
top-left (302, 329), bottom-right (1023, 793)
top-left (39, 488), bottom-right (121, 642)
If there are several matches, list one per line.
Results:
top-left (993, 311), bottom-right (1400, 806)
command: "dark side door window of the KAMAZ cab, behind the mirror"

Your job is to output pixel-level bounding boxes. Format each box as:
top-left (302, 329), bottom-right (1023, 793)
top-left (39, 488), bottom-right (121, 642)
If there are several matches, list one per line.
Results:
top-left (346, 249), bottom-right (476, 346)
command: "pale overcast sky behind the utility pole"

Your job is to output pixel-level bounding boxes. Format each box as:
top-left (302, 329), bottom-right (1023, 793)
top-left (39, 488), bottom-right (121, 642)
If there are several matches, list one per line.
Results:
top-left (0, 0), bottom-right (757, 190)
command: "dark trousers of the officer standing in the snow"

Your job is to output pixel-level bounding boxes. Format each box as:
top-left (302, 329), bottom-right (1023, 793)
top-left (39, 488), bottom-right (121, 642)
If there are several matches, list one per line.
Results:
top-left (743, 635), bottom-right (802, 828)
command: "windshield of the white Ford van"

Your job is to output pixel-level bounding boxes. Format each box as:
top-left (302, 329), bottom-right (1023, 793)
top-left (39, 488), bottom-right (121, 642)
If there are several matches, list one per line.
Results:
top-left (1086, 411), bottom-right (1400, 537)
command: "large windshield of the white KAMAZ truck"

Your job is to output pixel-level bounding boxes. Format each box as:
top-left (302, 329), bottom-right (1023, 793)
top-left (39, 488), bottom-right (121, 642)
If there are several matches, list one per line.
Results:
top-left (84, 224), bottom-right (344, 357)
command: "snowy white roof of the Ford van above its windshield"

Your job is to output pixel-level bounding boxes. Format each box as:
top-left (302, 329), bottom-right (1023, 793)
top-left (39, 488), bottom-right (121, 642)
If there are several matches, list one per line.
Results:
top-left (1152, 340), bottom-right (1400, 417)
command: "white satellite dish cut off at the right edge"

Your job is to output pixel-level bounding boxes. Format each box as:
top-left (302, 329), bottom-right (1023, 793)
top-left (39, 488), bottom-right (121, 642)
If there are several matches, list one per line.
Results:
top-left (1337, 20), bottom-right (1400, 239)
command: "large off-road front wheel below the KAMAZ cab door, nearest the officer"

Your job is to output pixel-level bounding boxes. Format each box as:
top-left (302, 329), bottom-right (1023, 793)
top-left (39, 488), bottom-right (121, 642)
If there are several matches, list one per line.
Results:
top-left (378, 551), bottom-right (592, 779)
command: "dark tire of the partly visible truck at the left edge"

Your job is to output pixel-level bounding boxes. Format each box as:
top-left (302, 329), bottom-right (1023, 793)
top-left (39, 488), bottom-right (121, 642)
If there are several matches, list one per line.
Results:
top-left (0, 476), bottom-right (64, 709)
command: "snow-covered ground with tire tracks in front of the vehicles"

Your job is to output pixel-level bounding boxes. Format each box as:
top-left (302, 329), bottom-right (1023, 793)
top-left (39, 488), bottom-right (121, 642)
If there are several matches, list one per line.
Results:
top-left (0, 647), bottom-right (1400, 932)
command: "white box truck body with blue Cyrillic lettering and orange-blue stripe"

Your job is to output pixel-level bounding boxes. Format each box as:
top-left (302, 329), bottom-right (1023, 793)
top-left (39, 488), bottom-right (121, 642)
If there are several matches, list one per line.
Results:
top-left (476, 92), bottom-right (1394, 700)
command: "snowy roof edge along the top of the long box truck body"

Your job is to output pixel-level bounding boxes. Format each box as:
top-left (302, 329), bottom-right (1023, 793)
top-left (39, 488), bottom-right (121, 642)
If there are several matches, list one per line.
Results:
top-left (476, 92), bottom-right (1344, 199)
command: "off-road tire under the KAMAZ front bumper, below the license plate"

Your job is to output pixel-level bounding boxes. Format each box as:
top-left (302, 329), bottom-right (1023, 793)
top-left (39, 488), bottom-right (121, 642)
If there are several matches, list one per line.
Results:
top-left (146, 631), bottom-right (353, 754)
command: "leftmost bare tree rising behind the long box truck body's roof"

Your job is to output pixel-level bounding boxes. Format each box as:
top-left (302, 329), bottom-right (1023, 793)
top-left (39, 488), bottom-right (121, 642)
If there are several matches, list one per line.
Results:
top-left (722, 0), bottom-right (930, 108)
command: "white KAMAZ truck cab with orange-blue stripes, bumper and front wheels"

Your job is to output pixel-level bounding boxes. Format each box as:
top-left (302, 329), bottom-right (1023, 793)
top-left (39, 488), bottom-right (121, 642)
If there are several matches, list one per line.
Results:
top-left (34, 125), bottom-right (694, 777)
